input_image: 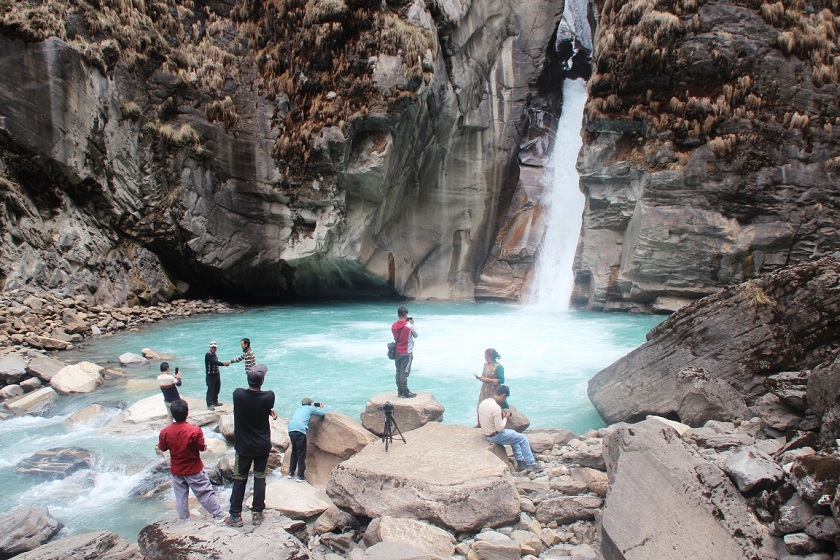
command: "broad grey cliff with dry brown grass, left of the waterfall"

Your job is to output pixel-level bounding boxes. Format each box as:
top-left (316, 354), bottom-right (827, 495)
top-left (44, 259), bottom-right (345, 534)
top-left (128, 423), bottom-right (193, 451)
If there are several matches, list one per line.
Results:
top-left (0, 0), bottom-right (562, 303)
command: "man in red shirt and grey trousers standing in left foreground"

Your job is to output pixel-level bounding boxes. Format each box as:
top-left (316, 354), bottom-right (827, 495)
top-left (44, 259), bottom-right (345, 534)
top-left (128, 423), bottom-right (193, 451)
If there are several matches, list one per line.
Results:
top-left (157, 399), bottom-right (225, 523)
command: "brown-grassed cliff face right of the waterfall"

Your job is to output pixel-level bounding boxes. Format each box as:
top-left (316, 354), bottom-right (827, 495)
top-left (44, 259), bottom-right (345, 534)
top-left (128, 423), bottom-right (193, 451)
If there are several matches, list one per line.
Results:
top-left (573, 0), bottom-right (840, 311)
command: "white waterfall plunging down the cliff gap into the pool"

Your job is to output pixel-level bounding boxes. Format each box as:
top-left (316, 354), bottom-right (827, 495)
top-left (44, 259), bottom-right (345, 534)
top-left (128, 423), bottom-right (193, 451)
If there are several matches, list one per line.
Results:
top-left (531, 79), bottom-right (586, 310)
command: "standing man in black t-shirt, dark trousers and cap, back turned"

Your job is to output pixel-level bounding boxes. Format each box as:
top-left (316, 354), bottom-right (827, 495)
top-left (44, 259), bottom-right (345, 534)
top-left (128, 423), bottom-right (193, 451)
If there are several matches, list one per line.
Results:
top-left (226, 364), bottom-right (277, 527)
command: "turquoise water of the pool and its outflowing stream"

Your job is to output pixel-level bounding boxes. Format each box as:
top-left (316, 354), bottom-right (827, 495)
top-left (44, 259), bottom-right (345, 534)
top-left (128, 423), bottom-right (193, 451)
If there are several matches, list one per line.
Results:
top-left (0, 302), bottom-right (662, 541)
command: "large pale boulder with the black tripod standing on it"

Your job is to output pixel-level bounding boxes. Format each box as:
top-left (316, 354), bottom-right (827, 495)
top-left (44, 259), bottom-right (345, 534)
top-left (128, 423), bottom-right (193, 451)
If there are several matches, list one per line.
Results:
top-left (327, 422), bottom-right (519, 531)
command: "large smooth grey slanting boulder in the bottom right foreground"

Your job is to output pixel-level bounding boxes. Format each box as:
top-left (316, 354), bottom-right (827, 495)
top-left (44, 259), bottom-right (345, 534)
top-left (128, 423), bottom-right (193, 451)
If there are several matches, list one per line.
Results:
top-left (602, 419), bottom-right (781, 560)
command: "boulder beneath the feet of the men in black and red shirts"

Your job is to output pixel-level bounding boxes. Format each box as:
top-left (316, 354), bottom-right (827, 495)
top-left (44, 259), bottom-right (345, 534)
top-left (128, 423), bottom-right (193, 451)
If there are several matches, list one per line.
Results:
top-left (137, 511), bottom-right (312, 560)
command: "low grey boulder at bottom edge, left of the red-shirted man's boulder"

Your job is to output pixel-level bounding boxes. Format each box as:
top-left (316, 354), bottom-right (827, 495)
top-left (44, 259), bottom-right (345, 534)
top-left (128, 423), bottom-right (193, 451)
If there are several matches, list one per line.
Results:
top-left (10, 531), bottom-right (143, 560)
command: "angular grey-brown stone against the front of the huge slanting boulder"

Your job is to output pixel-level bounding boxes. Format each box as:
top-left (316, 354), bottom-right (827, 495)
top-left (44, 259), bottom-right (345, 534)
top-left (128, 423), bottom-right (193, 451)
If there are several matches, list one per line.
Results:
top-left (676, 367), bottom-right (752, 427)
